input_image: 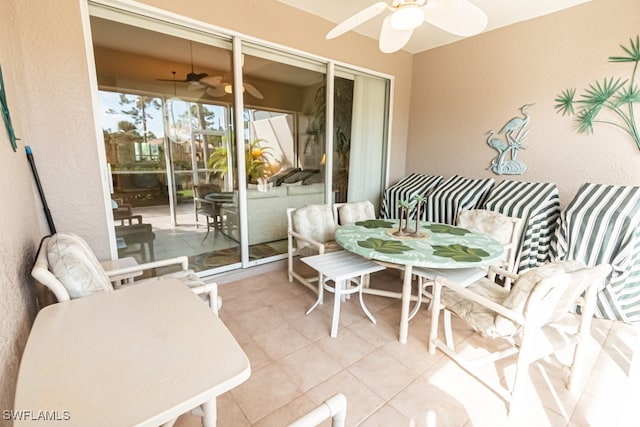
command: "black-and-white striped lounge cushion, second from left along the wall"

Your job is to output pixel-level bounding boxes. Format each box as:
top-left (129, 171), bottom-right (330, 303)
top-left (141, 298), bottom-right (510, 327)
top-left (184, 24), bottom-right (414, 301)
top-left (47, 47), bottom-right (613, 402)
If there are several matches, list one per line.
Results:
top-left (422, 175), bottom-right (495, 225)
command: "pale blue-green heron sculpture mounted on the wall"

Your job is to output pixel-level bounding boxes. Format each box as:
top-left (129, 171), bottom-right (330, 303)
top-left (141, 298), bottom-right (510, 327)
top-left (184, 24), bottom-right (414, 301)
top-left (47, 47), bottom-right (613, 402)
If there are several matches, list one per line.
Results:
top-left (487, 104), bottom-right (533, 175)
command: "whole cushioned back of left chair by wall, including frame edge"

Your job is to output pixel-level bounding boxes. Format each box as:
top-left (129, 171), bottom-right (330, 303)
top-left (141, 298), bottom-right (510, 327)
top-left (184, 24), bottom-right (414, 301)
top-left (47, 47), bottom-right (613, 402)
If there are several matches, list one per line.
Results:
top-left (31, 233), bottom-right (113, 301)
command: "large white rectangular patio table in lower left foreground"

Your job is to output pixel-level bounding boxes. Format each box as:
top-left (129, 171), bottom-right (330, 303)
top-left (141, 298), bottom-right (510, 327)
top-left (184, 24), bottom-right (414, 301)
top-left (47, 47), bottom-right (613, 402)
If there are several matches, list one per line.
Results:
top-left (11, 279), bottom-right (251, 427)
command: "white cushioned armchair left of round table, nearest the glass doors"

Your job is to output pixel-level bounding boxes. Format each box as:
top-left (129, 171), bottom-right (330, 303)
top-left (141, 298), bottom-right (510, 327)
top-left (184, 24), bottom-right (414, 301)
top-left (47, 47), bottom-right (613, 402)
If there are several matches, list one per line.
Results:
top-left (287, 205), bottom-right (339, 292)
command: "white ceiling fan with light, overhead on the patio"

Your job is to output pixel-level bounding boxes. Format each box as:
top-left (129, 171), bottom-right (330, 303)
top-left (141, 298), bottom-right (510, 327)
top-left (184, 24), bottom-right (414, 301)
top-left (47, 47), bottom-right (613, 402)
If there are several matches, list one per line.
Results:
top-left (326, 0), bottom-right (488, 53)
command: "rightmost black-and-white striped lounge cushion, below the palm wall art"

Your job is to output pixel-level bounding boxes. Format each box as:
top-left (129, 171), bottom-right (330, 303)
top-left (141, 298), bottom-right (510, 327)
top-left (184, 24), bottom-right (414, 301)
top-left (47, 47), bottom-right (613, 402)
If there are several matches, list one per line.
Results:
top-left (551, 184), bottom-right (640, 322)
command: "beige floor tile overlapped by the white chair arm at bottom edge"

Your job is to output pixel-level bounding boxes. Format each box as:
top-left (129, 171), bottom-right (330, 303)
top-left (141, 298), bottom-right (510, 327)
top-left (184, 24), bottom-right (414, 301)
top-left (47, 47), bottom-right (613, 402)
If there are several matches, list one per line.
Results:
top-left (306, 370), bottom-right (384, 426)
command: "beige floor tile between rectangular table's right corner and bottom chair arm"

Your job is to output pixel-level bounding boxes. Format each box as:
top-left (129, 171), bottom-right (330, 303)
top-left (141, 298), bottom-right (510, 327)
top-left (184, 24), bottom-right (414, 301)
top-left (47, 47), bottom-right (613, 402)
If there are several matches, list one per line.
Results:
top-left (231, 364), bottom-right (302, 424)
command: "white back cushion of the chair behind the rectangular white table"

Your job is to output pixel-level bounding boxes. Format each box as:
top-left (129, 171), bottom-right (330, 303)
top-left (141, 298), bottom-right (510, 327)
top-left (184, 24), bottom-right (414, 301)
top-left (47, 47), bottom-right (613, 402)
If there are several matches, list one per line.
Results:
top-left (47, 233), bottom-right (113, 299)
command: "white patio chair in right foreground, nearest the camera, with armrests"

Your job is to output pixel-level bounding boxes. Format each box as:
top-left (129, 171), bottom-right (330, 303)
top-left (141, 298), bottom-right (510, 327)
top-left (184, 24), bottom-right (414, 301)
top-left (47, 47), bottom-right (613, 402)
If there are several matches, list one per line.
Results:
top-left (429, 261), bottom-right (611, 418)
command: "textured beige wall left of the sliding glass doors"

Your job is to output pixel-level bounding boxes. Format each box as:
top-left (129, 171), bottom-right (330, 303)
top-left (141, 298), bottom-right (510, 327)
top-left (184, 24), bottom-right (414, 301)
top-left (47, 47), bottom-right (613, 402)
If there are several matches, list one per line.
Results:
top-left (0, 0), bottom-right (110, 414)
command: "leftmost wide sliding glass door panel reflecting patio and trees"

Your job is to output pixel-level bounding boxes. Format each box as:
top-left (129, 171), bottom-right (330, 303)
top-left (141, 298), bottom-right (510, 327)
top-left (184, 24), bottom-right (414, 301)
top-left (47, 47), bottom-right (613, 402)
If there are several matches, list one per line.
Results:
top-left (91, 16), bottom-right (240, 272)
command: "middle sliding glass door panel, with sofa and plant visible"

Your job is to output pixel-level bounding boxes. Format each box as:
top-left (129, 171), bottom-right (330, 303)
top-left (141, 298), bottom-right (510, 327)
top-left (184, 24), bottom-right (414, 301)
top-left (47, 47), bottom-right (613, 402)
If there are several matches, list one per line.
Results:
top-left (242, 43), bottom-right (326, 262)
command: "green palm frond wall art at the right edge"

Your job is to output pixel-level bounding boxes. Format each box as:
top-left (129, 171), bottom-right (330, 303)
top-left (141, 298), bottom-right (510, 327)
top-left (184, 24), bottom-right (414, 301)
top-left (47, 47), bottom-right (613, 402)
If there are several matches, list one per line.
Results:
top-left (555, 36), bottom-right (640, 149)
